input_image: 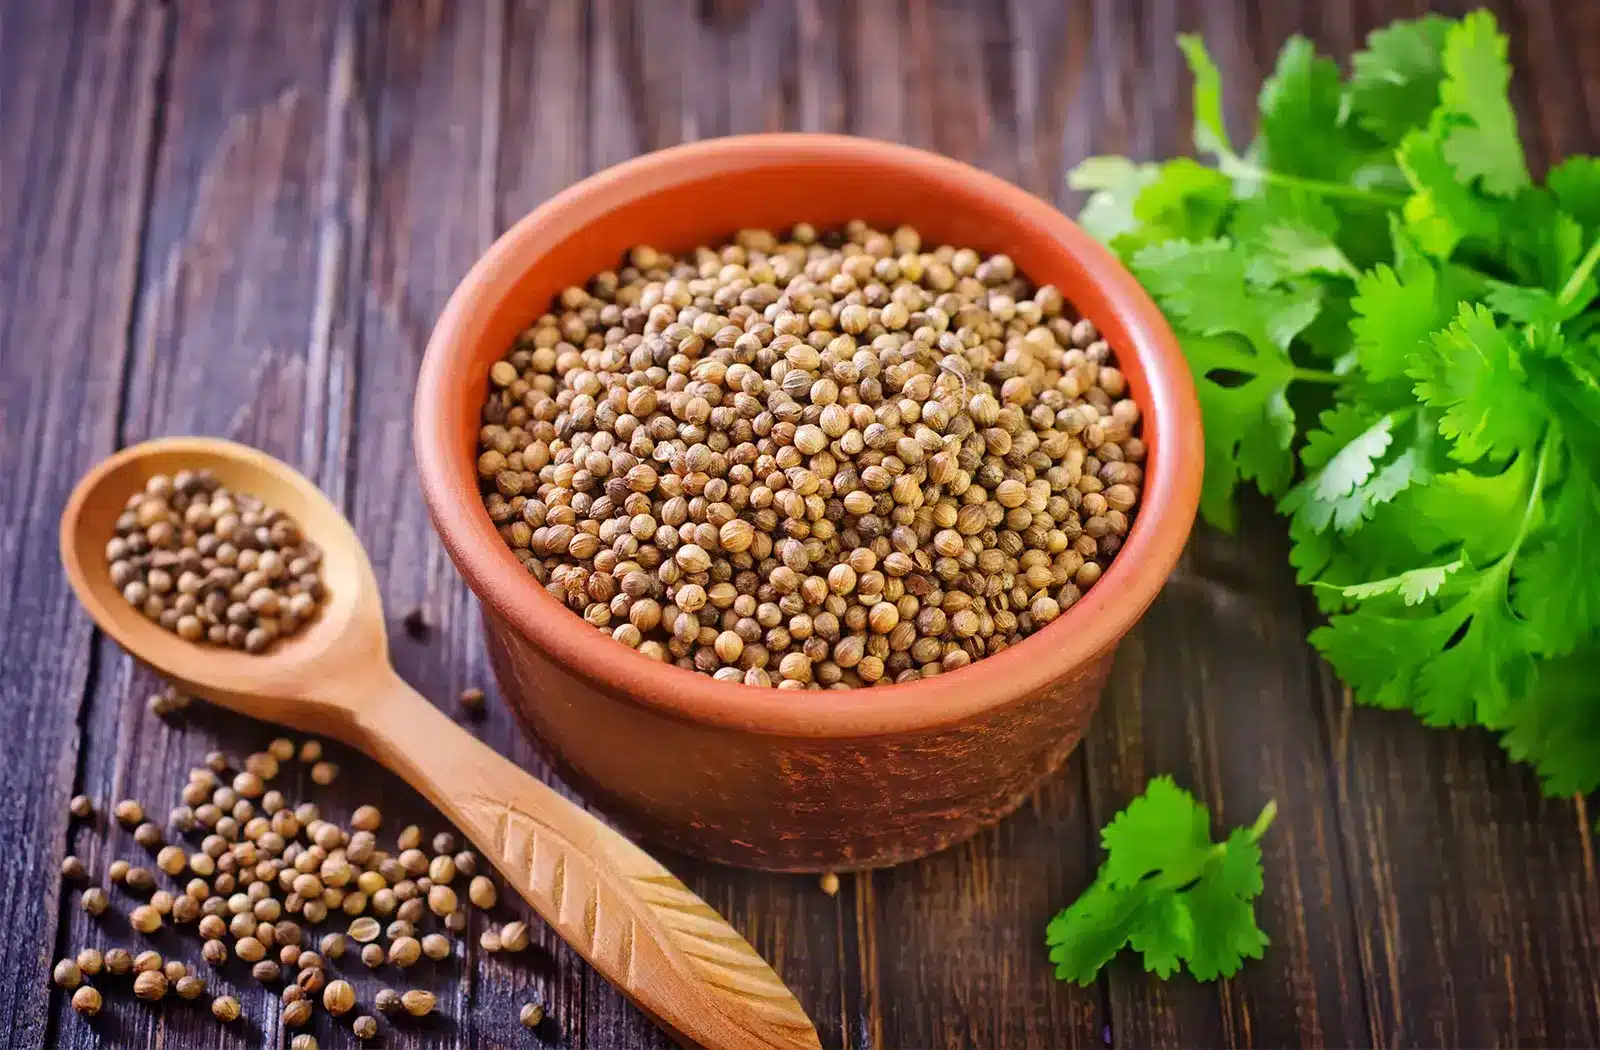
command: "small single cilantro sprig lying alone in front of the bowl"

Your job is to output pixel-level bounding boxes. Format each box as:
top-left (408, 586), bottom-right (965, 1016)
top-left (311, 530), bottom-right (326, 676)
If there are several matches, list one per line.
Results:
top-left (1045, 776), bottom-right (1277, 984)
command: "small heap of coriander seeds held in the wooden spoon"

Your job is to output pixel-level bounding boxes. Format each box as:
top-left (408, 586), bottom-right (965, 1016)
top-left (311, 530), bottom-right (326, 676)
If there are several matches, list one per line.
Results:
top-left (106, 471), bottom-right (326, 653)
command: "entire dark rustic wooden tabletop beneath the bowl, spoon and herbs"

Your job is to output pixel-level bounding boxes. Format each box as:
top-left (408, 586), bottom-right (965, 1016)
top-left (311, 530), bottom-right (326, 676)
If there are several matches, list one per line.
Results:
top-left (0, 0), bottom-right (1600, 1050)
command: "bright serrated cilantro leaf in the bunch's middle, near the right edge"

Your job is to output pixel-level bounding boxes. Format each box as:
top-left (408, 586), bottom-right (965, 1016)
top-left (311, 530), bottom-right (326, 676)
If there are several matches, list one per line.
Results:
top-left (1410, 304), bottom-right (1542, 463)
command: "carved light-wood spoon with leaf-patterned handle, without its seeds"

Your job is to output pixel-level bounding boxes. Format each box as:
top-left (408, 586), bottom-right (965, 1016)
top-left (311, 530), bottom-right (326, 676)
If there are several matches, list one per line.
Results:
top-left (61, 437), bottom-right (821, 1050)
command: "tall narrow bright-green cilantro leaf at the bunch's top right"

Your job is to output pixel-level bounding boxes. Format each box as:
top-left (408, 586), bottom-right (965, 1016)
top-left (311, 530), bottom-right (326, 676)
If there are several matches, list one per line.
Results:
top-left (1435, 11), bottom-right (1528, 197)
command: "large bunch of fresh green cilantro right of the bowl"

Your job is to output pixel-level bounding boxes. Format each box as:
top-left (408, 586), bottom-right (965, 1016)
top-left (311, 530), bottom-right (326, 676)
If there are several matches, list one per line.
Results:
top-left (1070, 11), bottom-right (1600, 800)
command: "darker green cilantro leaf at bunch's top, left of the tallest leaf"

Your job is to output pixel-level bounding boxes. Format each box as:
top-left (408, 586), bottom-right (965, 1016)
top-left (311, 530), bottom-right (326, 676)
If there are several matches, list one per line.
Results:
top-left (1350, 14), bottom-right (1453, 144)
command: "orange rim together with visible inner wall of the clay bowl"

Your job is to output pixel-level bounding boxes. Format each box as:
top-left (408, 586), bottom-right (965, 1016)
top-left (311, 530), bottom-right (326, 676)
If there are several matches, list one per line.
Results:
top-left (416, 134), bottom-right (1200, 730)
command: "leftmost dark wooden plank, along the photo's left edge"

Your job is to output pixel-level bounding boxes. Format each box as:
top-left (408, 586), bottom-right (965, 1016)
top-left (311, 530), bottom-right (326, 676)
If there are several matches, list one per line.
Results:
top-left (0, 3), bottom-right (163, 1047)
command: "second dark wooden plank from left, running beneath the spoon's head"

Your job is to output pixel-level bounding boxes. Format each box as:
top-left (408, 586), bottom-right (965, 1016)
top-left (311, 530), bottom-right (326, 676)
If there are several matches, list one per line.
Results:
top-left (53, 2), bottom-right (374, 1047)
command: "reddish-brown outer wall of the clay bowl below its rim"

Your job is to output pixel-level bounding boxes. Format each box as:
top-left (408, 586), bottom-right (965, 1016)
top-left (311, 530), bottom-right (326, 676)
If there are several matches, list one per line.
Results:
top-left (485, 610), bottom-right (1112, 871)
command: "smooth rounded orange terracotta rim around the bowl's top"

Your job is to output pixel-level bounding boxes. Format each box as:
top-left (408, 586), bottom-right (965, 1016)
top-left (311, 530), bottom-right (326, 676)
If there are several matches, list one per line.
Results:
top-left (413, 133), bottom-right (1202, 738)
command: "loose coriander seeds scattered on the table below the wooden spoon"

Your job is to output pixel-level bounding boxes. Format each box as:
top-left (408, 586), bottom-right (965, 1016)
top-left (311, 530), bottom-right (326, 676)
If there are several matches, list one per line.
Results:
top-left (51, 738), bottom-right (546, 1050)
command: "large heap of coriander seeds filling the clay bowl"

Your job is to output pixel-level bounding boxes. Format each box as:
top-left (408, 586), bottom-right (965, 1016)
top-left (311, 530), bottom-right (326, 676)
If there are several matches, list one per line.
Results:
top-left (477, 222), bottom-right (1146, 688)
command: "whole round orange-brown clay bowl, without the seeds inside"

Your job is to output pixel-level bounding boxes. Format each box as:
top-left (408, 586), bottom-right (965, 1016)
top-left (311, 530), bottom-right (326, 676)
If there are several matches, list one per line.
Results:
top-left (414, 134), bottom-right (1202, 871)
